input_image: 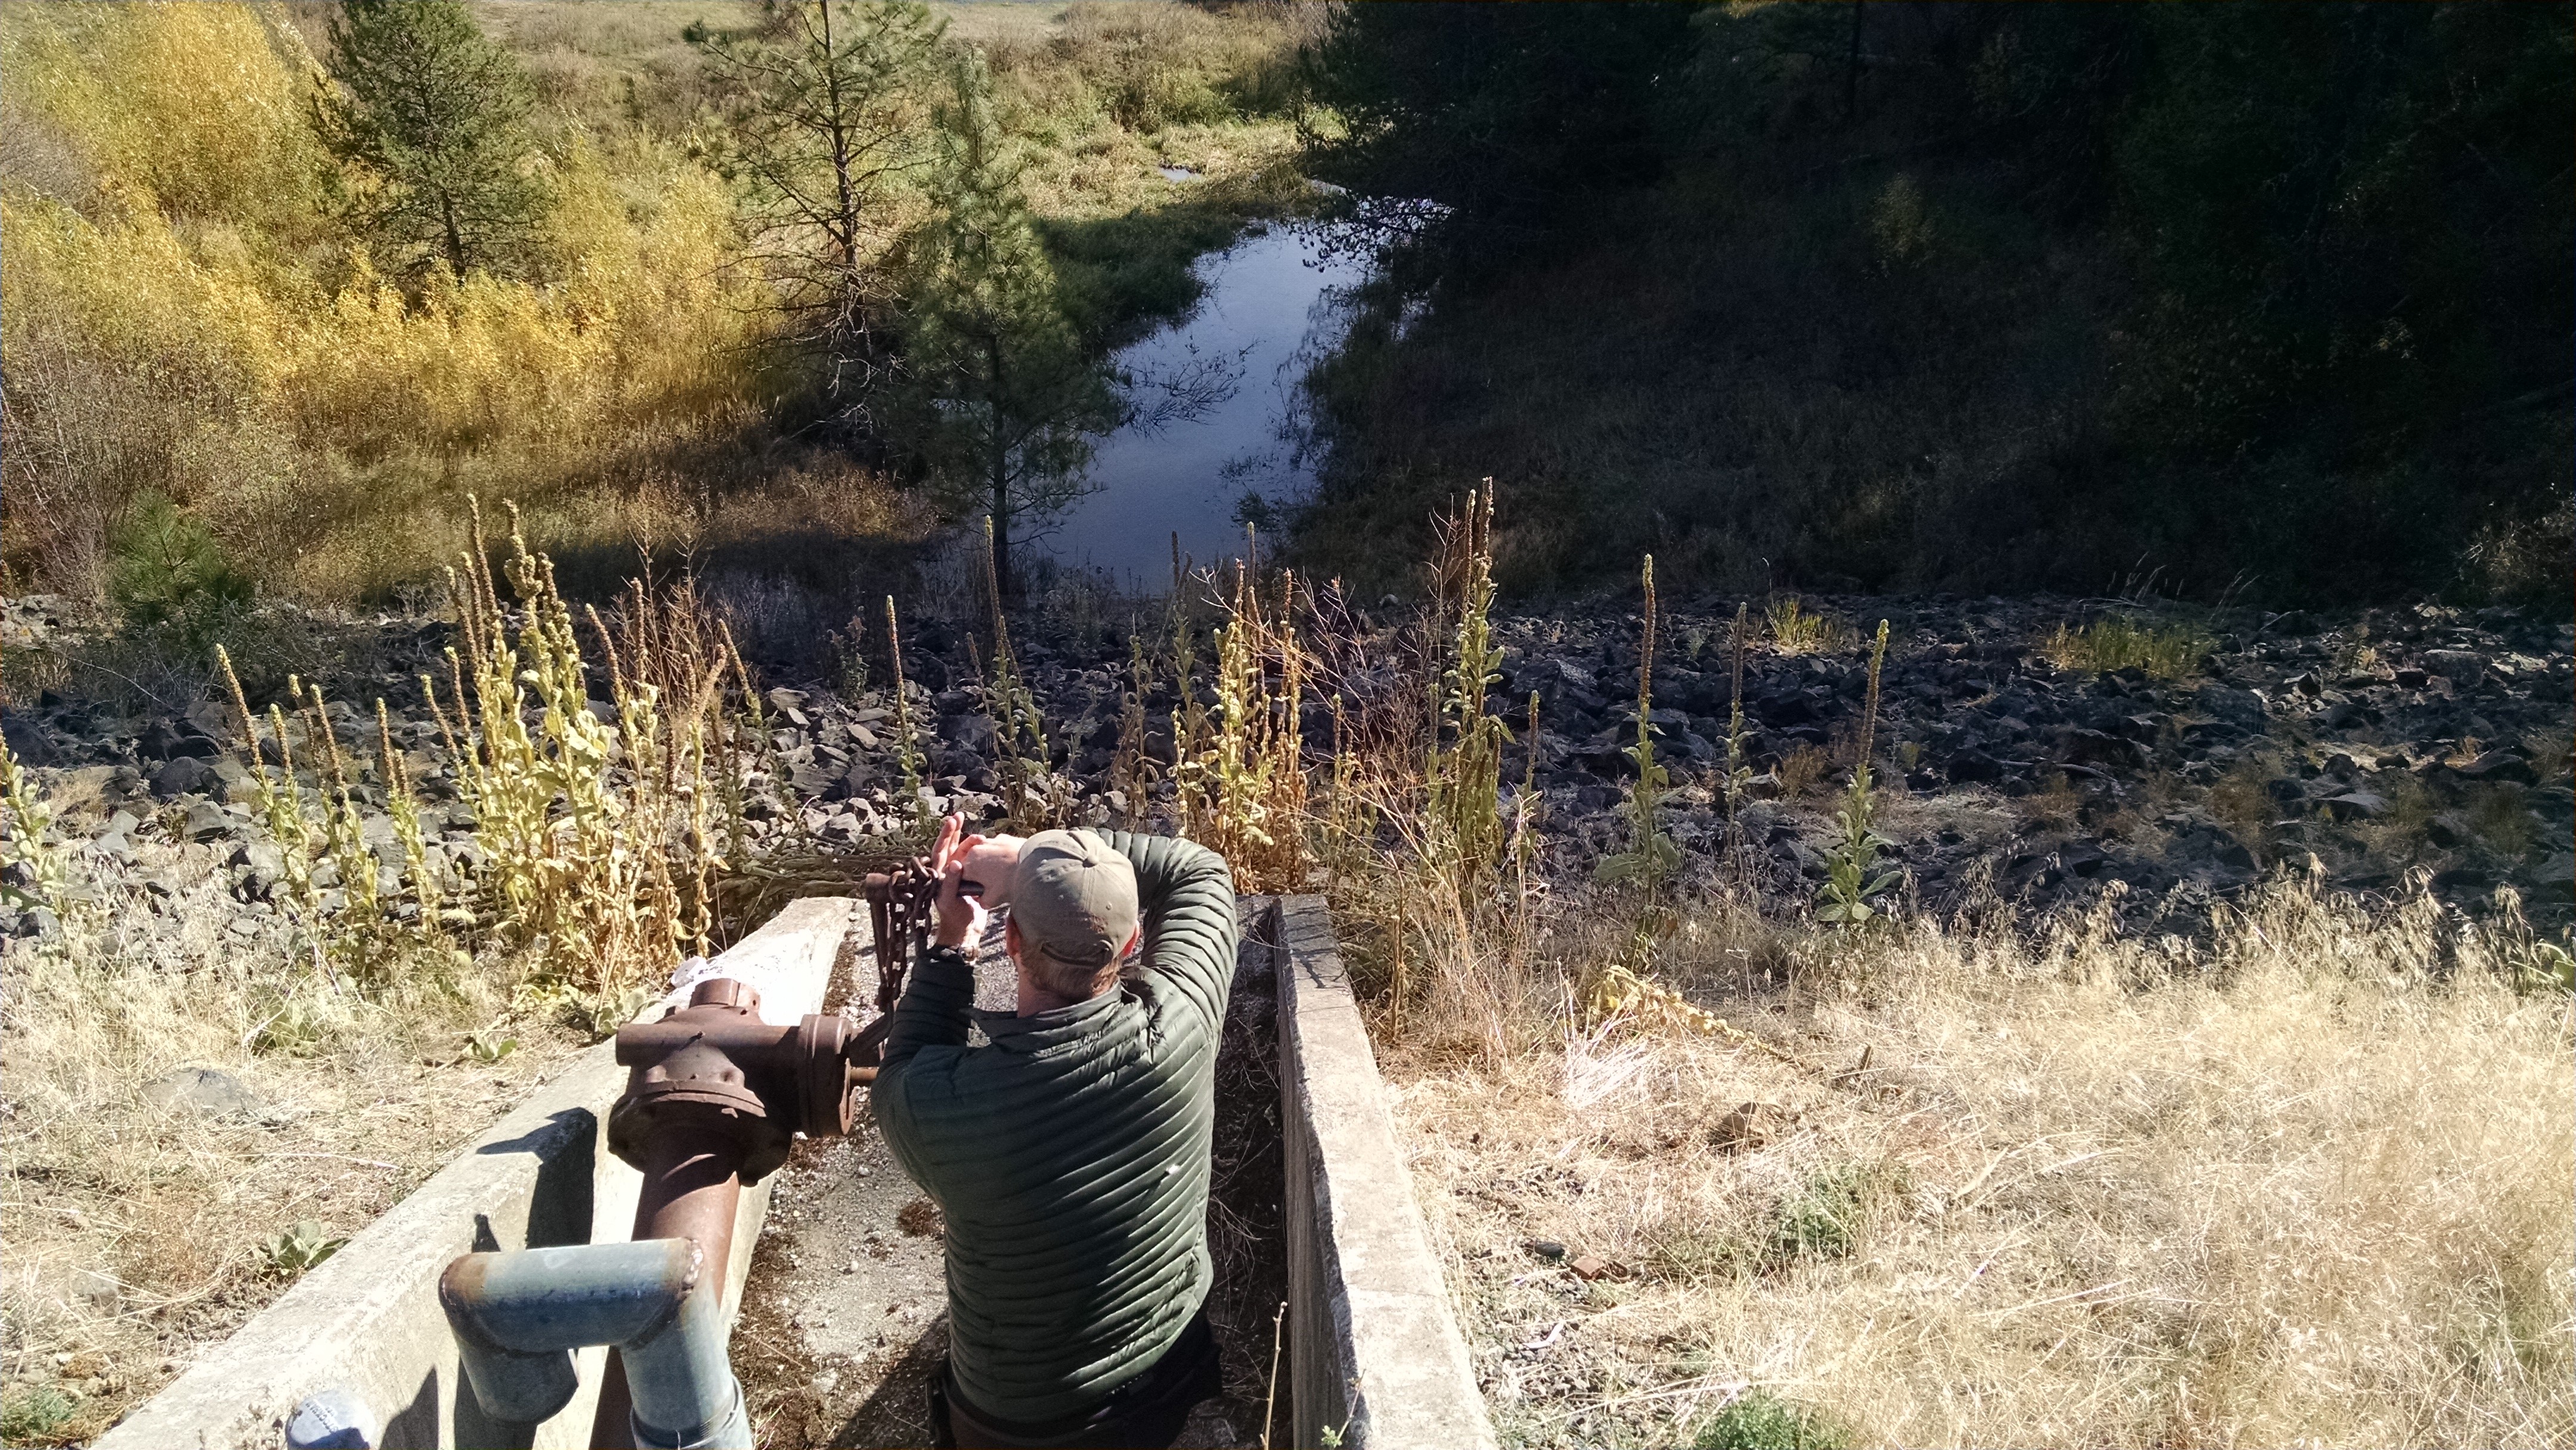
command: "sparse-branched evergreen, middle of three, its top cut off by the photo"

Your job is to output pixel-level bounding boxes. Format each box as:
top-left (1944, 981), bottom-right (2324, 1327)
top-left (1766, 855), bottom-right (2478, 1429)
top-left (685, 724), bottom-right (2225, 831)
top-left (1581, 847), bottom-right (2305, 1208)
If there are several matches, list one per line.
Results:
top-left (683, 0), bottom-right (943, 410)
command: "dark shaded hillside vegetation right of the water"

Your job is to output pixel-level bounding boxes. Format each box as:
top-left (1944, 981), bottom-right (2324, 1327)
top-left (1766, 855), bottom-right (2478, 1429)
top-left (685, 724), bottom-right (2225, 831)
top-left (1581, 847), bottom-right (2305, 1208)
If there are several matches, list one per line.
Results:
top-left (1298, 2), bottom-right (2576, 608)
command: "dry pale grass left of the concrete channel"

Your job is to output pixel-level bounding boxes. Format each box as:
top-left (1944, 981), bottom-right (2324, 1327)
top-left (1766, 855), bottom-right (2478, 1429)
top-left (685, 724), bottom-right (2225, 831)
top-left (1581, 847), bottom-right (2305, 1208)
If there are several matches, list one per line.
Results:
top-left (0, 847), bottom-right (580, 1445)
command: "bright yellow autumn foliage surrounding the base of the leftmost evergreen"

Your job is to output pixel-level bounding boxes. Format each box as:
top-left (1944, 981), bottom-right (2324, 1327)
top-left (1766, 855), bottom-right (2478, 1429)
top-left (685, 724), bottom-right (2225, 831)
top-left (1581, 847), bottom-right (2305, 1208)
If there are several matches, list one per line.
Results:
top-left (0, 2), bottom-right (763, 597)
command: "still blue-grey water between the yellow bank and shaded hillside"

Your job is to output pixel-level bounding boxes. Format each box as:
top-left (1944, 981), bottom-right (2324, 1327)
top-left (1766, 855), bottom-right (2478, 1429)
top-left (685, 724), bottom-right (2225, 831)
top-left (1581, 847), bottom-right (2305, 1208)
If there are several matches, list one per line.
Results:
top-left (1041, 224), bottom-right (1366, 590)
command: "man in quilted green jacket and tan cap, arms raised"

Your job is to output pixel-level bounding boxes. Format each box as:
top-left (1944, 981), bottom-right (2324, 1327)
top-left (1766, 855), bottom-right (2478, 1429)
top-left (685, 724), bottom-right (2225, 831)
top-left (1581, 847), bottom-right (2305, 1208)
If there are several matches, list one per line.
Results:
top-left (871, 816), bottom-right (1237, 1445)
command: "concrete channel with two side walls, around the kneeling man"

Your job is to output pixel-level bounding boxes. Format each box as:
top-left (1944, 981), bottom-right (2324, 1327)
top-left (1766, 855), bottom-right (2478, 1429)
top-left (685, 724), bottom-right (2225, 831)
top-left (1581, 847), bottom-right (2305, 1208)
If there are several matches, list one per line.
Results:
top-left (98, 896), bottom-right (1494, 1450)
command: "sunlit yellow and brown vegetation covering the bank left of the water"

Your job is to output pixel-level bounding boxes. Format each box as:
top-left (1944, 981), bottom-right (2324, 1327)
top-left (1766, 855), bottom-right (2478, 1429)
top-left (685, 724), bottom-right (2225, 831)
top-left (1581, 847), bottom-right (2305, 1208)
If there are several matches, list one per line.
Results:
top-left (0, 2), bottom-right (1293, 613)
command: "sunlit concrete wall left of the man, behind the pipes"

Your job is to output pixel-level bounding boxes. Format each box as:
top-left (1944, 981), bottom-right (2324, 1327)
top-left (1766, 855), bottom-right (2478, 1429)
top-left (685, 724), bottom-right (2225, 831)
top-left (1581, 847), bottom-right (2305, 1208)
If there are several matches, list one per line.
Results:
top-left (95, 896), bottom-right (868, 1450)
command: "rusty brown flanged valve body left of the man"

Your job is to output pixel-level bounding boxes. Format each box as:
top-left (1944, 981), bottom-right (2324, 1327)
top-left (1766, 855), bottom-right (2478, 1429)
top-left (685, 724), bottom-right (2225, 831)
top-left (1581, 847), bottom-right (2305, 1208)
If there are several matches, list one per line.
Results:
top-left (608, 976), bottom-right (878, 1182)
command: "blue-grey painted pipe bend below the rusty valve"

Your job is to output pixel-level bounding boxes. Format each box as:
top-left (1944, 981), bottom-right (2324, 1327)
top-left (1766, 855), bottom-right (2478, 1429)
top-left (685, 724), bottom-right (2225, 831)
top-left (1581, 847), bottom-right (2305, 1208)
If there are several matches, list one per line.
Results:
top-left (438, 1239), bottom-right (752, 1450)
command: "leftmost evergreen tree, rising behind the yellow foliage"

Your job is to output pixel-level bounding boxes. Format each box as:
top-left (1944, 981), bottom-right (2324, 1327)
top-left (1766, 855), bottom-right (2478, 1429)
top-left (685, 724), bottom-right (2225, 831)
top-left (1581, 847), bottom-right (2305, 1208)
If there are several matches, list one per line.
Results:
top-left (317, 0), bottom-right (549, 275)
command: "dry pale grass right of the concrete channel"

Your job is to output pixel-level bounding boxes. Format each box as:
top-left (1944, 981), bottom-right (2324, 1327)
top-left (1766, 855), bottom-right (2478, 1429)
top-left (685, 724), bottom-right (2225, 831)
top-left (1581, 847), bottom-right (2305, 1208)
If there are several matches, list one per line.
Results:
top-left (1388, 881), bottom-right (2576, 1445)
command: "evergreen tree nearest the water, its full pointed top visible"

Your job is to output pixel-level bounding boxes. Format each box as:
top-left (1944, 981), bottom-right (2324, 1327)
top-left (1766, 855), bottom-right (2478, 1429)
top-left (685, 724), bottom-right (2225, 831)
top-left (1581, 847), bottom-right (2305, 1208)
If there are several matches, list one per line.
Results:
top-left (904, 57), bottom-right (1131, 597)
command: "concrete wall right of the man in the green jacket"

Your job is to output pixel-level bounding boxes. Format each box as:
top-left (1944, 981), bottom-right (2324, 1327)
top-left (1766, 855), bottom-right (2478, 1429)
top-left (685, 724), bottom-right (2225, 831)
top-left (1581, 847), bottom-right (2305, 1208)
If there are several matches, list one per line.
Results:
top-left (1265, 896), bottom-right (1494, 1450)
